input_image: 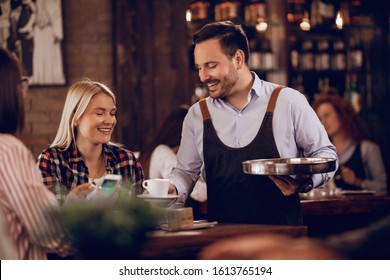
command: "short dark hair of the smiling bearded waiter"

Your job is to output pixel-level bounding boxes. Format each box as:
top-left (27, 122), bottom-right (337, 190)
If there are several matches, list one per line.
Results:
top-left (192, 21), bottom-right (249, 64)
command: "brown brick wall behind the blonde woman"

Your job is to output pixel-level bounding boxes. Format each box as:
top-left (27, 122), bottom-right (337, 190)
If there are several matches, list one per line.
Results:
top-left (21, 0), bottom-right (114, 157)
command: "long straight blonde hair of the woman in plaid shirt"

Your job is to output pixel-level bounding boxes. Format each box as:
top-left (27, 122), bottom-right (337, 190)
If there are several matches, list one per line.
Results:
top-left (50, 79), bottom-right (116, 151)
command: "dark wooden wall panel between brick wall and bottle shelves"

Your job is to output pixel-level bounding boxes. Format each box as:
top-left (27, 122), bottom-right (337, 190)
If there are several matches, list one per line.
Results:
top-left (113, 0), bottom-right (192, 151)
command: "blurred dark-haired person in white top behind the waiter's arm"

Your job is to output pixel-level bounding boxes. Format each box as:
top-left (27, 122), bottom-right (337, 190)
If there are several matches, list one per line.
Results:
top-left (139, 105), bottom-right (207, 218)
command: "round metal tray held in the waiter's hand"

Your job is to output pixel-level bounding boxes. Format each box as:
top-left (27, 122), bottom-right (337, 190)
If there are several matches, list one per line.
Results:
top-left (242, 158), bottom-right (336, 175)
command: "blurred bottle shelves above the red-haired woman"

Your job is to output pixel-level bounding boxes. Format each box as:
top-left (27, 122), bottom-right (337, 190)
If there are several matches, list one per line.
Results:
top-left (287, 0), bottom-right (375, 103)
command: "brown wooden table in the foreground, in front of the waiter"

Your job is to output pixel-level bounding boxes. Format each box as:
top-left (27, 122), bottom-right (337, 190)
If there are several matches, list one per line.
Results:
top-left (141, 224), bottom-right (307, 260)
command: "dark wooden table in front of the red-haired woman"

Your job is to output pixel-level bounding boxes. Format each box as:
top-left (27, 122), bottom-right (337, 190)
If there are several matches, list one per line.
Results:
top-left (301, 195), bottom-right (390, 237)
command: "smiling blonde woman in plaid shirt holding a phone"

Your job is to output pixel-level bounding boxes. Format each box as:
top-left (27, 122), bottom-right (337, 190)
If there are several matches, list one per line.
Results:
top-left (38, 80), bottom-right (144, 197)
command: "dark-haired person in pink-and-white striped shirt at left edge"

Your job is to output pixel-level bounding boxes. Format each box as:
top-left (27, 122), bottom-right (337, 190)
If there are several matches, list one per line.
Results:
top-left (0, 49), bottom-right (71, 260)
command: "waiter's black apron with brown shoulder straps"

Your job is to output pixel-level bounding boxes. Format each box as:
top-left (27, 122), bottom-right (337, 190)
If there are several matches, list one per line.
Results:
top-left (200, 87), bottom-right (302, 225)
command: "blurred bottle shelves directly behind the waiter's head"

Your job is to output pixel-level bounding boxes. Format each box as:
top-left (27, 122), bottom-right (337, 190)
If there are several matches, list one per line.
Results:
top-left (187, 0), bottom-right (286, 83)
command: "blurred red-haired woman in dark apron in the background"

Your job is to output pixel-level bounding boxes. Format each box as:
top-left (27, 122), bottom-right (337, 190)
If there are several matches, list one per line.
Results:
top-left (313, 94), bottom-right (387, 194)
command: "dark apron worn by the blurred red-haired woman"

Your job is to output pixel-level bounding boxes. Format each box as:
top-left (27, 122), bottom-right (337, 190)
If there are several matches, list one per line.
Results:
top-left (334, 144), bottom-right (366, 190)
